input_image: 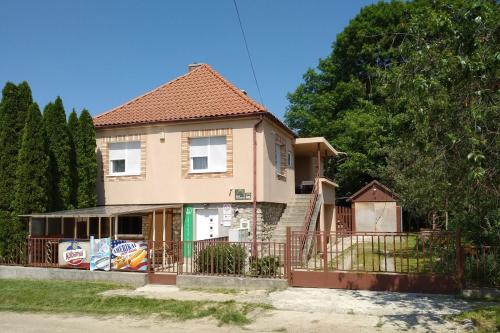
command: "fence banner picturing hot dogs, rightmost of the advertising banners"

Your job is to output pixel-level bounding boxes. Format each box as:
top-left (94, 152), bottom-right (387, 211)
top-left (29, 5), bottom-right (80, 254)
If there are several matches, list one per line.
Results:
top-left (111, 240), bottom-right (148, 271)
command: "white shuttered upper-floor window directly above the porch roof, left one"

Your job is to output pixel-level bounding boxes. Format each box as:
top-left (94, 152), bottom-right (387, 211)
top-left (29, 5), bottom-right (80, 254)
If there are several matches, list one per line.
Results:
top-left (109, 141), bottom-right (141, 176)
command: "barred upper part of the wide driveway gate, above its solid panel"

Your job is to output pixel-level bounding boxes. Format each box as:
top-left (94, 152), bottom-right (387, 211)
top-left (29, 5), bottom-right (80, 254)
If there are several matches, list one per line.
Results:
top-left (291, 231), bottom-right (457, 274)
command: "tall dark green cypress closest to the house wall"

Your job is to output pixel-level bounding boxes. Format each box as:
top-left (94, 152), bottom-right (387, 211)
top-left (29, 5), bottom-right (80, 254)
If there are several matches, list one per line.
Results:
top-left (76, 109), bottom-right (97, 208)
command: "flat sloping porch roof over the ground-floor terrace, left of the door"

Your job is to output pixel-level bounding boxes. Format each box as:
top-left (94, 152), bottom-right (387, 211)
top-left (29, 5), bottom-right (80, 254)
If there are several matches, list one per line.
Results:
top-left (19, 205), bottom-right (182, 218)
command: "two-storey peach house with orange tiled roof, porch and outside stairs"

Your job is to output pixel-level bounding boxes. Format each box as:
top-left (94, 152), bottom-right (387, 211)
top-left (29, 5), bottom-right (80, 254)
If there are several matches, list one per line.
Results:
top-left (23, 64), bottom-right (337, 249)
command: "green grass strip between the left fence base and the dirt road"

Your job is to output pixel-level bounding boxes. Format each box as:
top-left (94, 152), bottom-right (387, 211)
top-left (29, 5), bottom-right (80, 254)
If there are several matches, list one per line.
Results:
top-left (0, 280), bottom-right (271, 325)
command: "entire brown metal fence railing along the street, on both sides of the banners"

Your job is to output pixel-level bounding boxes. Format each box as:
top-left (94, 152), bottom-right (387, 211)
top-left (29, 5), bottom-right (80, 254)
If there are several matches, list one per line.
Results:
top-left (0, 231), bottom-right (500, 287)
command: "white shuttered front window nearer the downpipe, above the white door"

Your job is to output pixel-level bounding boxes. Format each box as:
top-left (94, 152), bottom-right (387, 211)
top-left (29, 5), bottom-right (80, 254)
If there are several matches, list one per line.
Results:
top-left (189, 136), bottom-right (227, 173)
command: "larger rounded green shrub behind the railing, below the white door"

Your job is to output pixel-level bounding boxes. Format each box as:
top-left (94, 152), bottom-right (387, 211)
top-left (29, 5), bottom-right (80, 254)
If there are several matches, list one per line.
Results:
top-left (195, 243), bottom-right (247, 274)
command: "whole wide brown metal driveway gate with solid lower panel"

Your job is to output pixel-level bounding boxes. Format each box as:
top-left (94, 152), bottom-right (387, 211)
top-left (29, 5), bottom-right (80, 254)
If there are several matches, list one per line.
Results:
top-left (287, 230), bottom-right (463, 293)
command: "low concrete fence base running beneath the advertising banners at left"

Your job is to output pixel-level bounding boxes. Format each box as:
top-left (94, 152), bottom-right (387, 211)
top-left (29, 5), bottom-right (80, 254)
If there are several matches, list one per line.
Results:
top-left (0, 266), bottom-right (147, 287)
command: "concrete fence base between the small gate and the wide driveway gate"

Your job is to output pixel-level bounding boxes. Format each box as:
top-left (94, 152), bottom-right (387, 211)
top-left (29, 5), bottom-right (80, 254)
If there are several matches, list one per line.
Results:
top-left (176, 275), bottom-right (288, 290)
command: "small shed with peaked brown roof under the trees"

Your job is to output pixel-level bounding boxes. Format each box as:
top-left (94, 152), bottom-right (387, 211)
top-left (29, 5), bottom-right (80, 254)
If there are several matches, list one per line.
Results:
top-left (348, 180), bottom-right (403, 232)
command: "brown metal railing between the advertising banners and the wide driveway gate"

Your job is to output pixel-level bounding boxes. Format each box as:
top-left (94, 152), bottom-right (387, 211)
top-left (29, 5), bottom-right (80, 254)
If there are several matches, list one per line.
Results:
top-left (150, 240), bottom-right (286, 279)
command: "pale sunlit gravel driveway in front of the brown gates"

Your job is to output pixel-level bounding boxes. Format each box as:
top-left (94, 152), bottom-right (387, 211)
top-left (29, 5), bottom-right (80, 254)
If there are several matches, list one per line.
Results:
top-left (97, 285), bottom-right (491, 333)
